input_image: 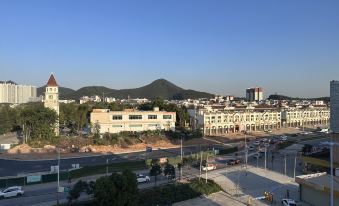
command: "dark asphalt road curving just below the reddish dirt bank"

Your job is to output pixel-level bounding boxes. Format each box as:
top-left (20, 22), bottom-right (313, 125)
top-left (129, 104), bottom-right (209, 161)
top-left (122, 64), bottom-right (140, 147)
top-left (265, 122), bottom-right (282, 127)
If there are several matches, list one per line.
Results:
top-left (0, 145), bottom-right (234, 177)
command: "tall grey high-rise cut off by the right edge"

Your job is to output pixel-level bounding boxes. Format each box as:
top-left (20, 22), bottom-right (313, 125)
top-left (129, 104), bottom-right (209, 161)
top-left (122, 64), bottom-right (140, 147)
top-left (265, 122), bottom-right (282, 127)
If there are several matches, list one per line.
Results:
top-left (330, 81), bottom-right (339, 163)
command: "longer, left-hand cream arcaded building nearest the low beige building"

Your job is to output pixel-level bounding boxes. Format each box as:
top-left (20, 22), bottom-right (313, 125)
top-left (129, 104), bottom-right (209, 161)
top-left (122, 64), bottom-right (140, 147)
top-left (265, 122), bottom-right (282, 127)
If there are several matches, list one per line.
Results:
top-left (188, 105), bottom-right (281, 135)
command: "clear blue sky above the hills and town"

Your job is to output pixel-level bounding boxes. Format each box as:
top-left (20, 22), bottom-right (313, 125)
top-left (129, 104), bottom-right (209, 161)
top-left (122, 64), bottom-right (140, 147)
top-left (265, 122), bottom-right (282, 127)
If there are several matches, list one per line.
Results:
top-left (0, 0), bottom-right (339, 97)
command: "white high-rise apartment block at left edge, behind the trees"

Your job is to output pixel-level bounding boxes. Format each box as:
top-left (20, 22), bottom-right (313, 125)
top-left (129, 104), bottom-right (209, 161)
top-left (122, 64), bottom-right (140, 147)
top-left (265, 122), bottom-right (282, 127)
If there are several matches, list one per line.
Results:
top-left (0, 82), bottom-right (37, 104)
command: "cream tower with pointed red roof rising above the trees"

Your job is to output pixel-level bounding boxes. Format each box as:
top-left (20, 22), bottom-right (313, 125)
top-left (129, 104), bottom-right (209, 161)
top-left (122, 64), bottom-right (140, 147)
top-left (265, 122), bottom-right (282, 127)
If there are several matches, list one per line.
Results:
top-left (44, 74), bottom-right (59, 135)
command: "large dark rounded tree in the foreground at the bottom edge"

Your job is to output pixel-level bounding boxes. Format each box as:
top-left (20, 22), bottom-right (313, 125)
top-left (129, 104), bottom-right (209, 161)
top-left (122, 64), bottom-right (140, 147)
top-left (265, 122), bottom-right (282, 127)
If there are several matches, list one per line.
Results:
top-left (93, 170), bottom-right (139, 206)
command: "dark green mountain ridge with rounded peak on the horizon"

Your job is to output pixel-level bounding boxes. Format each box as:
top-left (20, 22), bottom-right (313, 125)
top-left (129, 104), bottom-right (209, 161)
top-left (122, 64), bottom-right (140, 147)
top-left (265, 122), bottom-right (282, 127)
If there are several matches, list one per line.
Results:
top-left (38, 79), bottom-right (214, 100)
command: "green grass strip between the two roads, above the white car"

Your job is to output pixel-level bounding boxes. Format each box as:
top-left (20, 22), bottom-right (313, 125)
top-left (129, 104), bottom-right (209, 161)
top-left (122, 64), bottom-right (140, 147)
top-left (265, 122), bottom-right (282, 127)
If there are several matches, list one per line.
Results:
top-left (70, 161), bottom-right (146, 179)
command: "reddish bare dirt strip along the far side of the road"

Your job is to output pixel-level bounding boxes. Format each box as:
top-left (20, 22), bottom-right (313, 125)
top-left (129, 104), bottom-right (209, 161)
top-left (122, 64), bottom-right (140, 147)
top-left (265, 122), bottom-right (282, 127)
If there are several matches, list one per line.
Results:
top-left (0, 128), bottom-right (300, 160)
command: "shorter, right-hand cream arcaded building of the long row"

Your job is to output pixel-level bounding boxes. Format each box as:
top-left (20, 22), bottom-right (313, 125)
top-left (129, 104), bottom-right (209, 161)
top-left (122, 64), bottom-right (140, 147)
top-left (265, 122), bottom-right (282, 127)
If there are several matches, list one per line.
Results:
top-left (281, 104), bottom-right (330, 127)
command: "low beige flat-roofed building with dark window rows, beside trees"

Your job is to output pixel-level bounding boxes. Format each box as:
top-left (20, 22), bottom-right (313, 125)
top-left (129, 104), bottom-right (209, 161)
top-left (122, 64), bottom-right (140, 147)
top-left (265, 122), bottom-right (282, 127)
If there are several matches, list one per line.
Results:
top-left (91, 108), bottom-right (176, 134)
